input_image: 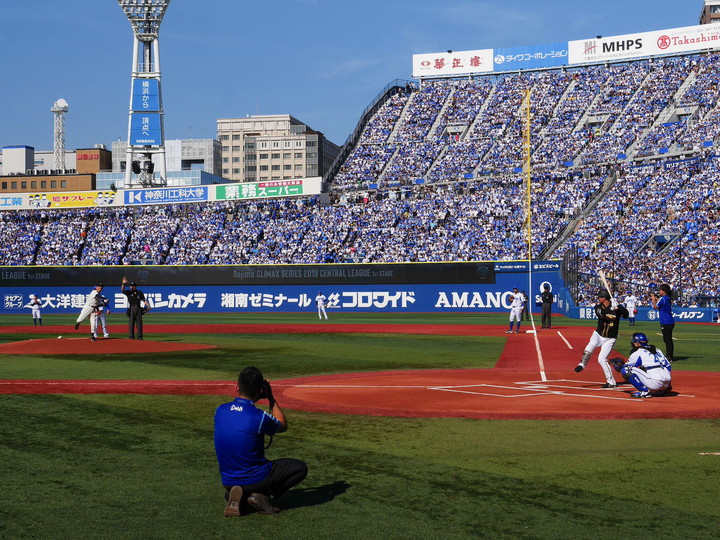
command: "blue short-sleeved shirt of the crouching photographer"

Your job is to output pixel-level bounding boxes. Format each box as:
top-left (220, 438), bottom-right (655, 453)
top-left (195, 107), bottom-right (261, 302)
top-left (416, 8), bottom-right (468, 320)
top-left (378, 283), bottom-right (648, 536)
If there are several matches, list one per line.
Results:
top-left (215, 397), bottom-right (280, 486)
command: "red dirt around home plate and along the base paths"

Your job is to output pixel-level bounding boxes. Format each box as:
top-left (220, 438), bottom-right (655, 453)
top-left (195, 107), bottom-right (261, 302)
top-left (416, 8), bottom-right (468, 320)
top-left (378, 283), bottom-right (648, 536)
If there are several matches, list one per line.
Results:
top-left (0, 324), bottom-right (720, 420)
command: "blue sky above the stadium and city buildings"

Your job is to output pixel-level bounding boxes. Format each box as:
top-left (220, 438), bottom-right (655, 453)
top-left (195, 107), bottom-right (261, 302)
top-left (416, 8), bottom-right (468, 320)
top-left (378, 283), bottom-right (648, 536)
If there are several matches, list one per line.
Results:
top-left (0, 0), bottom-right (703, 150)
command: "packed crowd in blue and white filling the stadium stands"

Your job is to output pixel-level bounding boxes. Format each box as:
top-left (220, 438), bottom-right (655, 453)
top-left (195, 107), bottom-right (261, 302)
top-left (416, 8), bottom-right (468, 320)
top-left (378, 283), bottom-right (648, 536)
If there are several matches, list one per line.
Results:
top-left (0, 54), bottom-right (720, 301)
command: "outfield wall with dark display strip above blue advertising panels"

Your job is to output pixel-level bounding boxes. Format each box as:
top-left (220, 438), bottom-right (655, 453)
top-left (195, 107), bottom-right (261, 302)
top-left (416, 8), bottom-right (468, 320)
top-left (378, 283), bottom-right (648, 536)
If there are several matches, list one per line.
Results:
top-left (0, 261), bottom-right (563, 314)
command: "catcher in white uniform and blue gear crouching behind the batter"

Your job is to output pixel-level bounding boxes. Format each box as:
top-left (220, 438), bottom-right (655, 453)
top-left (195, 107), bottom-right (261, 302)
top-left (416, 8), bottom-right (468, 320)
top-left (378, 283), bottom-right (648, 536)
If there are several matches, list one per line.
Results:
top-left (610, 332), bottom-right (672, 398)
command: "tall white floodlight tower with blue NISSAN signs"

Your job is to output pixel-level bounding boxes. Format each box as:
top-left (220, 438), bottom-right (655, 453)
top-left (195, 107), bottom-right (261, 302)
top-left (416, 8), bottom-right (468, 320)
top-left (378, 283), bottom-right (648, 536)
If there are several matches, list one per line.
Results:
top-left (118, 0), bottom-right (170, 188)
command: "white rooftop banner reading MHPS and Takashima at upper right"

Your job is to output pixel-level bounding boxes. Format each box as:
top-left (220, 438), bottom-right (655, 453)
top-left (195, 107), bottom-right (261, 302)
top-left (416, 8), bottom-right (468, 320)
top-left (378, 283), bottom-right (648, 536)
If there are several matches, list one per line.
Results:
top-left (568, 24), bottom-right (720, 65)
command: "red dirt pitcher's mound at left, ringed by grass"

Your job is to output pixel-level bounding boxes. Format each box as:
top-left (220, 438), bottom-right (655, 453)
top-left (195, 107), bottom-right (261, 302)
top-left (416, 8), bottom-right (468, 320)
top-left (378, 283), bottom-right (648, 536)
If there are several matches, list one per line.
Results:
top-left (0, 337), bottom-right (215, 355)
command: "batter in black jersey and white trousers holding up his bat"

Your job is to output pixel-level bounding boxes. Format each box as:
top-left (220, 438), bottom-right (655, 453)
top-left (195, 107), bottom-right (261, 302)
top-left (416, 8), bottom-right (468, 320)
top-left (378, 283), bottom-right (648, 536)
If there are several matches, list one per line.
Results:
top-left (575, 289), bottom-right (628, 388)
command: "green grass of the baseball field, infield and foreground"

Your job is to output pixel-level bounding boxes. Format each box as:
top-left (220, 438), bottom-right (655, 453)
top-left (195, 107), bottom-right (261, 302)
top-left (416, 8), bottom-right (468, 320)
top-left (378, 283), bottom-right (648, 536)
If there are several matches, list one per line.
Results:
top-left (0, 314), bottom-right (720, 539)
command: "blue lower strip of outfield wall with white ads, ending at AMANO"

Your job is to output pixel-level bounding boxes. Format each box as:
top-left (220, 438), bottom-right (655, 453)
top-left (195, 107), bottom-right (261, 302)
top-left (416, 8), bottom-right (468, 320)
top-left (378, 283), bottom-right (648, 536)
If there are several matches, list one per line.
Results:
top-left (2, 279), bottom-right (556, 314)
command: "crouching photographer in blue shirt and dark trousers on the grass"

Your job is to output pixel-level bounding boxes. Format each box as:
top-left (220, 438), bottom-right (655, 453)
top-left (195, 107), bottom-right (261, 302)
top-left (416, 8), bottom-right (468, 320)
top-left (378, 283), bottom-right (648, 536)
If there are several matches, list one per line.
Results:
top-left (215, 367), bottom-right (308, 517)
